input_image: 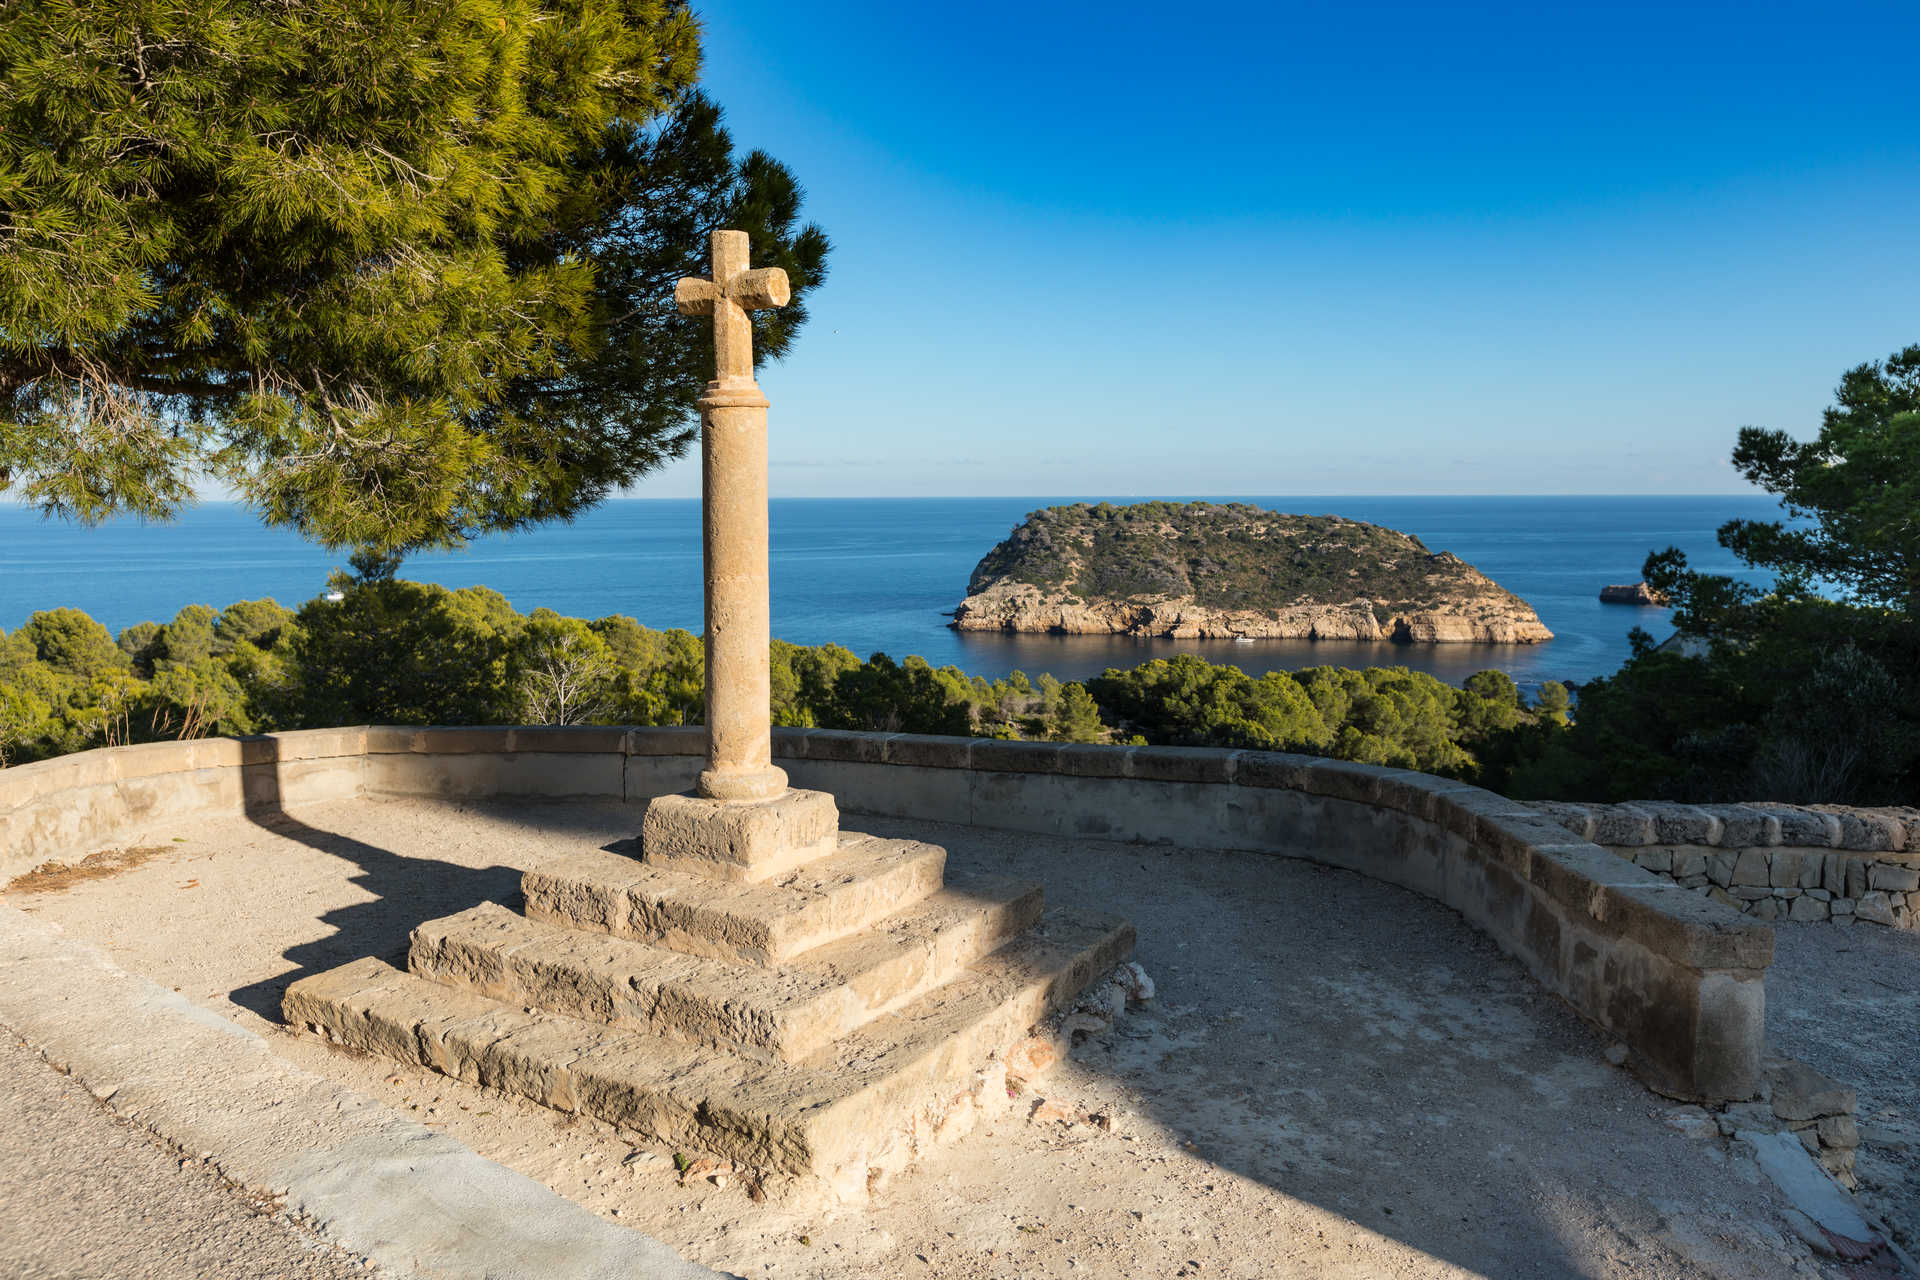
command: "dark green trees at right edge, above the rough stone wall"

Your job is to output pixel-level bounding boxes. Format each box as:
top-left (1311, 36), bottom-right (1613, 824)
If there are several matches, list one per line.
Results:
top-left (1509, 345), bottom-right (1920, 804)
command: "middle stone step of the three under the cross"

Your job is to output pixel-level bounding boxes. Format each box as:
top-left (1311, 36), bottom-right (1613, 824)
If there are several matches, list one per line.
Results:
top-left (407, 879), bottom-right (1041, 1061)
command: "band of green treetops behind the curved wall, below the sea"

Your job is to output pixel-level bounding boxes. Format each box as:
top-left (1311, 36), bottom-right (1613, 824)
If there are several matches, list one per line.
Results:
top-left (0, 578), bottom-right (1569, 785)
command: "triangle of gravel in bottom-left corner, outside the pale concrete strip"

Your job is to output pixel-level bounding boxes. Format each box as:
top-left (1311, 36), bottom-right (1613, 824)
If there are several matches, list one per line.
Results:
top-left (0, 1027), bottom-right (380, 1280)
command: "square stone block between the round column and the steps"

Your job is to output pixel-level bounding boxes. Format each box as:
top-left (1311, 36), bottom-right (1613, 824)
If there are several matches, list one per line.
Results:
top-left (639, 791), bottom-right (839, 881)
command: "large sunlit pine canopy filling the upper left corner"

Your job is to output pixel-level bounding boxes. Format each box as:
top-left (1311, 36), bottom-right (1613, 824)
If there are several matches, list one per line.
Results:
top-left (0, 0), bottom-right (828, 553)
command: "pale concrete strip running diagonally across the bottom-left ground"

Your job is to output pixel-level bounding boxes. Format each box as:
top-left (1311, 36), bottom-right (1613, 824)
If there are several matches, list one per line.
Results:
top-left (0, 904), bottom-right (729, 1280)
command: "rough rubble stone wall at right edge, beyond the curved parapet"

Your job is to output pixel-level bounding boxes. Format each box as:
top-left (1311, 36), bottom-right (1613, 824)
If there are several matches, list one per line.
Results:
top-left (1534, 802), bottom-right (1920, 929)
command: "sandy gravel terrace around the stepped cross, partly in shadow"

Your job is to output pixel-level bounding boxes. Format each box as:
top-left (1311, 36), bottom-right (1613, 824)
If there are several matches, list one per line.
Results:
top-left (8, 800), bottom-right (1920, 1280)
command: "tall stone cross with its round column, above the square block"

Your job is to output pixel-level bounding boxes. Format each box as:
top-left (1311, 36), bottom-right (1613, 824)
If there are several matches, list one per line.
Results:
top-left (674, 230), bottom-right (791, 800)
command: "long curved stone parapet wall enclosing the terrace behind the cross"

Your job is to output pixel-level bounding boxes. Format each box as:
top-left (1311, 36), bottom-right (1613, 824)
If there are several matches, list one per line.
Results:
top-left (0, 727), bottom-right (1772, 1100)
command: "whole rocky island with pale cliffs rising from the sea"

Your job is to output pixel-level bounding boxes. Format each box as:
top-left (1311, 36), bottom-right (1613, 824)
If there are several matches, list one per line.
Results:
top-left (952, 503), bottom-right (1553, 645)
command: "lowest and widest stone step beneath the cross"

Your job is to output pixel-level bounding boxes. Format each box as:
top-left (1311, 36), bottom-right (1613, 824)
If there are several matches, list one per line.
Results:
top-left (284, 912), bottom-right (1133, 1199)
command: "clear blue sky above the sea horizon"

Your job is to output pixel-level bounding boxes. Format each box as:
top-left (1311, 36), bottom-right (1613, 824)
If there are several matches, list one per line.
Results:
top-left (636, 0), bottom-right (1920, 497)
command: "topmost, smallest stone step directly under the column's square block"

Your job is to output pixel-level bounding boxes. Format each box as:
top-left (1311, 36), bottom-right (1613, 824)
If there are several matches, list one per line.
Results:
top-left (520, 831), bottom-right (947, 965)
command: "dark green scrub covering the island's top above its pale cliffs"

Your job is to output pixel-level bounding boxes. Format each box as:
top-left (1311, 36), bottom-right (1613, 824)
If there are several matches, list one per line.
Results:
top-left (968, 503), bottom-right (1528, 620)
